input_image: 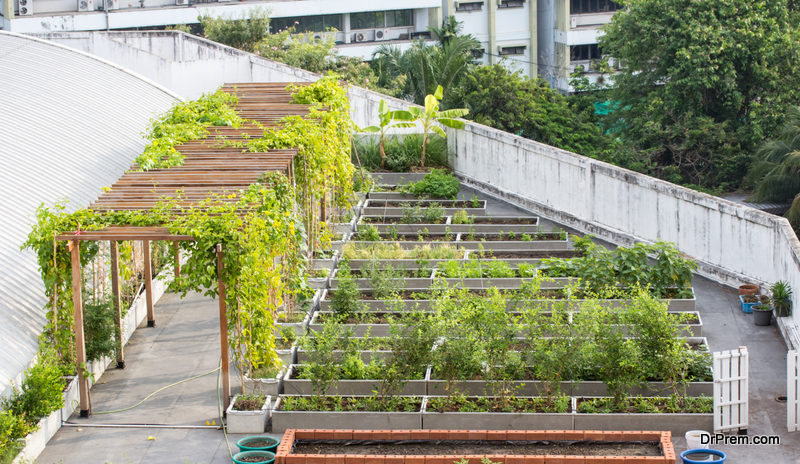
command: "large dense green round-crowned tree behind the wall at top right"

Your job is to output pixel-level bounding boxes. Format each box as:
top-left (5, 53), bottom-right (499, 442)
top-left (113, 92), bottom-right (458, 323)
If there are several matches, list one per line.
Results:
top-left (600, 0), bottom-right (800, 187)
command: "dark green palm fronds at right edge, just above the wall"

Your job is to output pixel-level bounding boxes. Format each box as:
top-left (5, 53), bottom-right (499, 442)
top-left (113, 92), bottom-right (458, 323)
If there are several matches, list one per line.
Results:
top-left (748, 107), bottom-right (800, 230)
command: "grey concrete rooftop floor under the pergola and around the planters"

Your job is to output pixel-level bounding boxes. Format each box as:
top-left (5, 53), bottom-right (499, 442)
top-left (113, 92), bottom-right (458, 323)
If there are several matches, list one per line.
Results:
top-left (36, 187), bottom-right (800, 464)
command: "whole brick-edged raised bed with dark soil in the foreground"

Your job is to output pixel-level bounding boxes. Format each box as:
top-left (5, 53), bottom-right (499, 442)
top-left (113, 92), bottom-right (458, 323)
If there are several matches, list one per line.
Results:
top-left (276, 429), bottom-right (675, 464)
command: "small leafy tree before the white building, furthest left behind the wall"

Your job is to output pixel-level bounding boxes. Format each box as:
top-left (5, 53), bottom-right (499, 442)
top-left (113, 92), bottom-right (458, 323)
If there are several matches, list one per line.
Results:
top-left (198, 8), bottom-right (269, 52)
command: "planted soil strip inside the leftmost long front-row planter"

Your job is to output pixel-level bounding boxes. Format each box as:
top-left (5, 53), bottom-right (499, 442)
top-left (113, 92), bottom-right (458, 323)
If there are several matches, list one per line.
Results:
top-left (279, 395), bottom-right (422, 412)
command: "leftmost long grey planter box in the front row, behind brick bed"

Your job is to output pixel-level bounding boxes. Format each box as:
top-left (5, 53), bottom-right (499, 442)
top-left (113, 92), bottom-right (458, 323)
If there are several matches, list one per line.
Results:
top-left (272, 397), bottom-right (422, 433)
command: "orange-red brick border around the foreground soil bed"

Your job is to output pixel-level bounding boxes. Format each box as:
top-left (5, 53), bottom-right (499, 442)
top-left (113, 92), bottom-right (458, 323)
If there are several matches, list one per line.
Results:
top-left (275, 429), bottom-right (675, 464)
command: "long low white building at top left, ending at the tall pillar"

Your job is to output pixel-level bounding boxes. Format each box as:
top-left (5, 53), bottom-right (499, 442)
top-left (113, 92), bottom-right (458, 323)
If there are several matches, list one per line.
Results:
top-left (0, 0), bottom-right (441, 58)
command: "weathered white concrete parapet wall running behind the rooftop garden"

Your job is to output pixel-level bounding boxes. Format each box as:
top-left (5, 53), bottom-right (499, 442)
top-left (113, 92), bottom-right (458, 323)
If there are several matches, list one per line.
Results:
top-left (37, 33), bottom-right (800, 345)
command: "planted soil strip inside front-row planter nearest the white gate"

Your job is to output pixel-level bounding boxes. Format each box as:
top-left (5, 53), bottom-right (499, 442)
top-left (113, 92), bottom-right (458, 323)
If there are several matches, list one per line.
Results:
top-left (578, 396), bottom-right (714, 414)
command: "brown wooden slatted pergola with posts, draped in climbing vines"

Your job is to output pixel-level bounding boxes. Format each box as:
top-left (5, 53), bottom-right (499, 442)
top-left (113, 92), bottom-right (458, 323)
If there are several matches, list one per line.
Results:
top-left (56, 83), bottom-right (309, 417)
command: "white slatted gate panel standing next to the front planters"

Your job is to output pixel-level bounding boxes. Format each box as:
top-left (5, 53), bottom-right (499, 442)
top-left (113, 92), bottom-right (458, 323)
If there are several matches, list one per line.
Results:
top-left (713, 346), bottom-right (750, 432)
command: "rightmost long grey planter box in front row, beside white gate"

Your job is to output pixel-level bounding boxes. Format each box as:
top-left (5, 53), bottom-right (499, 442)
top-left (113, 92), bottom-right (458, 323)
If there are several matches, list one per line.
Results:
top-left (573, 398), bottom-right (714, 436)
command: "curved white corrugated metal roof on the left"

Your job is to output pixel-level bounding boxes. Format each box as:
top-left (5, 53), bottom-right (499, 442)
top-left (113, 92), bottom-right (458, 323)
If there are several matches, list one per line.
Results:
top-left (0, 31), bottom-right (178, 394)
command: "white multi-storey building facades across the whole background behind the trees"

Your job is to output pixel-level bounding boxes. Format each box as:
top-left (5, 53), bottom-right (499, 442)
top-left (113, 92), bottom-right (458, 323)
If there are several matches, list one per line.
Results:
top-left (0, 0), bottom-right (620, 92)
